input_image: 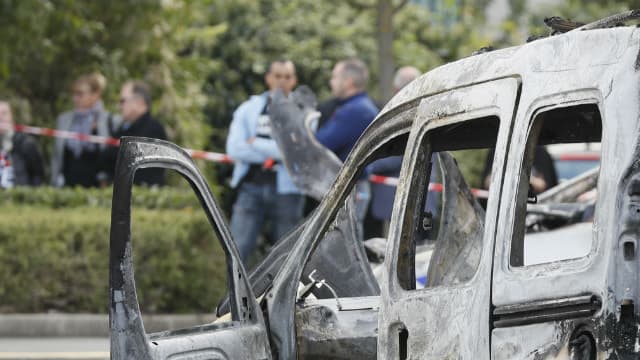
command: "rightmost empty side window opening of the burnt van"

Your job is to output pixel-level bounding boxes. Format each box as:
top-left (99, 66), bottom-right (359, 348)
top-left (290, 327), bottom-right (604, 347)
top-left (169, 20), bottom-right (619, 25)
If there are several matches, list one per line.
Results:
top-left (510, 104), bottom-right (602, 267)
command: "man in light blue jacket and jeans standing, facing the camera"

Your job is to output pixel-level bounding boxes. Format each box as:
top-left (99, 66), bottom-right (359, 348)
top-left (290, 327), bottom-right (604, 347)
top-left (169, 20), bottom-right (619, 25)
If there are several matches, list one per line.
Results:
top-left (226, 60), bottom-right (304, 261)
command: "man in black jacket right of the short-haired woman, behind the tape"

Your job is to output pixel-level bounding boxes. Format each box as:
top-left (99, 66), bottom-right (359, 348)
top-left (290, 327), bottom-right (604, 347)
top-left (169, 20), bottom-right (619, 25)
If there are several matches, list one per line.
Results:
top-left (110, 81), bottom-right (167, 186)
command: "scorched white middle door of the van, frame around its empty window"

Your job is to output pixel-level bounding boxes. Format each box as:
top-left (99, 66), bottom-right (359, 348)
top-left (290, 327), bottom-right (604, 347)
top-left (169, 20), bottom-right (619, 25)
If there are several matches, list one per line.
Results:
top-left (378, 77), bottom-right (520, 359)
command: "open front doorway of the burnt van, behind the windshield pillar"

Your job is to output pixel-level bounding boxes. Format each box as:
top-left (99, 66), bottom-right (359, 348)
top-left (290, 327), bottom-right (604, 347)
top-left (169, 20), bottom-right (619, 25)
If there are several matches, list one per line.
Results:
top-left (295, 126), bottom-right (410, 359)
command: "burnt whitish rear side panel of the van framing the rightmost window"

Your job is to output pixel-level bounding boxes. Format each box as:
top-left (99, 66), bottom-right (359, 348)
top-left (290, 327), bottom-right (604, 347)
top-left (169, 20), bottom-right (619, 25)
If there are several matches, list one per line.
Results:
top-left (491, 89), bottom-right (616, 359)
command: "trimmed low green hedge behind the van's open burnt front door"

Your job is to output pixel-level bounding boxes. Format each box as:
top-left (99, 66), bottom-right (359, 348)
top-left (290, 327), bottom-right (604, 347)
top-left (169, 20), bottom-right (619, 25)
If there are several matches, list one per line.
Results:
top-left (0, 204), bottom-right (226, 313)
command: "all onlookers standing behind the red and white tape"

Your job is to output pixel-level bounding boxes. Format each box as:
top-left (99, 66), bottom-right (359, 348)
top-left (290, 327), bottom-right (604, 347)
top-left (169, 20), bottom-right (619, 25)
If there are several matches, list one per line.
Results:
top-left (0, 58), bottom-right (419, 260)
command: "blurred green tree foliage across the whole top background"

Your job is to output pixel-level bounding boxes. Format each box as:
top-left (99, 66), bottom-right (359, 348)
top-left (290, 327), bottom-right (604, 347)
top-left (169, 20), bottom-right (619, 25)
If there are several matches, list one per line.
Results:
top-left (0, 0), bottom-right (640, 190)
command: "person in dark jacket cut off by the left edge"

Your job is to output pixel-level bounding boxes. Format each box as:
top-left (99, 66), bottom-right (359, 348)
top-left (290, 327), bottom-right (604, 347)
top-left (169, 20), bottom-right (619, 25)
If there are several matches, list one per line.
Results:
top-left (0, 99), bottom-right (44, 188)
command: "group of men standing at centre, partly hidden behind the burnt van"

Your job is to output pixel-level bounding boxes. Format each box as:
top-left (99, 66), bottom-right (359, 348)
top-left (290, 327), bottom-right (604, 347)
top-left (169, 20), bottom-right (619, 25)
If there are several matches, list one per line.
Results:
top-left (226, 59), bottom-right (557, 262)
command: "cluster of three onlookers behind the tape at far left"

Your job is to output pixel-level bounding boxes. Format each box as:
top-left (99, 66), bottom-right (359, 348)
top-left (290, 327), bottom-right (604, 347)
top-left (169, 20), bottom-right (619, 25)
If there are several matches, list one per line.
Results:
top-left (0, 73), bottom-right (167, 188)
